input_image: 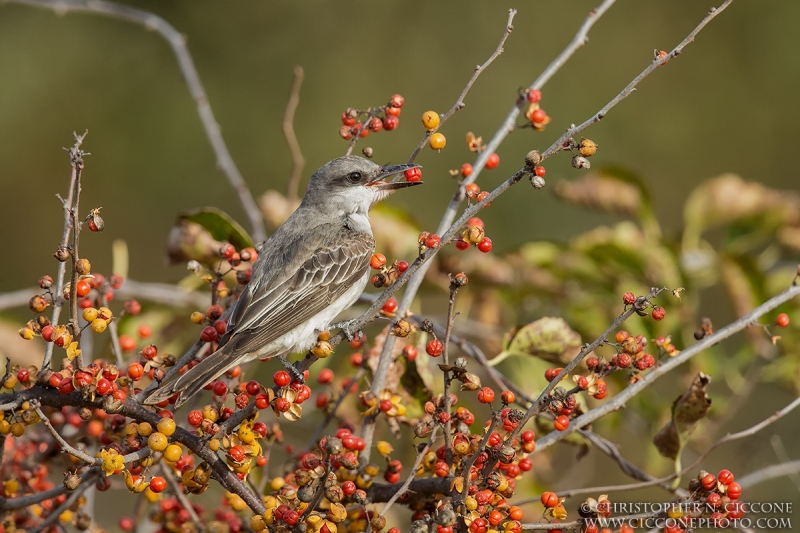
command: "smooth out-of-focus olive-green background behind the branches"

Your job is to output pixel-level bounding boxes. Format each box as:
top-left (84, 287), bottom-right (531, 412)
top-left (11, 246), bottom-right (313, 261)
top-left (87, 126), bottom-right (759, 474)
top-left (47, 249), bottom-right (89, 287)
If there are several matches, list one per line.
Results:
top-left (0, 0), bottom-right (800, 524)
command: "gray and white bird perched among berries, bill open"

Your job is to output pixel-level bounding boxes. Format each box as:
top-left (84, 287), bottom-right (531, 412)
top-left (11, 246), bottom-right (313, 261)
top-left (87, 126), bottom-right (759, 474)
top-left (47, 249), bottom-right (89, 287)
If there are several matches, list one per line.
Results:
top-left (144, 155), bottom-right (422, 408)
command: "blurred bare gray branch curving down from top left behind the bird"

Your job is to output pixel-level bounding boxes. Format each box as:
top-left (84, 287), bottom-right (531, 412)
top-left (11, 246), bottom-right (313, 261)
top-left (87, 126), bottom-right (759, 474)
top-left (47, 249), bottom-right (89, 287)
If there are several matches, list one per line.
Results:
top-left (4, 0), bottom-right (266, 242)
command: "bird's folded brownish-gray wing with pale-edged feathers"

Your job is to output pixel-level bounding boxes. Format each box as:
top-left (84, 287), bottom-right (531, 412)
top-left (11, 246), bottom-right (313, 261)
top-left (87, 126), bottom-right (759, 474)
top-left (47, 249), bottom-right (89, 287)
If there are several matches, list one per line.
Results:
top-left (226, 231), bottom-right (375, 353)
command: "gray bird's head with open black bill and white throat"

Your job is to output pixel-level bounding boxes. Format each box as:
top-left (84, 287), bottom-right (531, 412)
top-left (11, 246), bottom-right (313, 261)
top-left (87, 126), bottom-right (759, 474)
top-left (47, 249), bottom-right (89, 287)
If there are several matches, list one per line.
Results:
top-left (303, 155), bottom-right (422, 212)
